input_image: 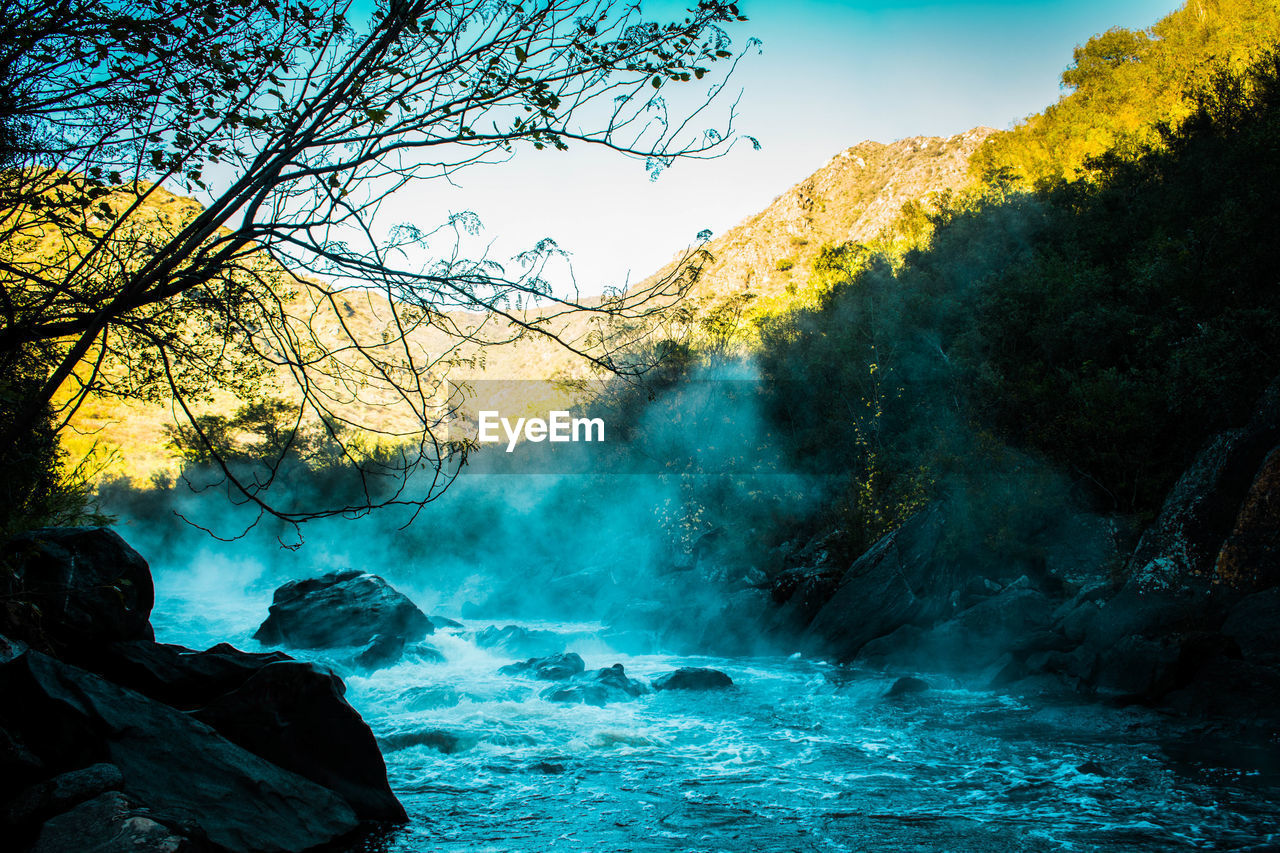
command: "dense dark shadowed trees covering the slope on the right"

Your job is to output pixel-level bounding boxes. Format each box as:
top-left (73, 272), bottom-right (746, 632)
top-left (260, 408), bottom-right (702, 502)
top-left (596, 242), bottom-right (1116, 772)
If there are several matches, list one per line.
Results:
top-left (760, 44), bottom-right (1280, 558)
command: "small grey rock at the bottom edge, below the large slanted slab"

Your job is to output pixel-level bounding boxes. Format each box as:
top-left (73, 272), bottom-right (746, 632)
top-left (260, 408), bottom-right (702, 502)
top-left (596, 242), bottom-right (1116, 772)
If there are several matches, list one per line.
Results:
top-left (32, 792), bottom-right (197, 853)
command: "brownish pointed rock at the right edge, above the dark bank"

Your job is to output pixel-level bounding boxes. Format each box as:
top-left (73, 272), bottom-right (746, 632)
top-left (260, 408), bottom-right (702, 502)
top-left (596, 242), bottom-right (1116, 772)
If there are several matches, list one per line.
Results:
top-left (1213, 447), bottom-right (1280, 590)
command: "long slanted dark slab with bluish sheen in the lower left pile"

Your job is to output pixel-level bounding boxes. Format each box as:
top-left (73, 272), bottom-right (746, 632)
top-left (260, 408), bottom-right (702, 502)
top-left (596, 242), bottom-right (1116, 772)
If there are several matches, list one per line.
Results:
top-left (0, 651), bottom-right (358, 852)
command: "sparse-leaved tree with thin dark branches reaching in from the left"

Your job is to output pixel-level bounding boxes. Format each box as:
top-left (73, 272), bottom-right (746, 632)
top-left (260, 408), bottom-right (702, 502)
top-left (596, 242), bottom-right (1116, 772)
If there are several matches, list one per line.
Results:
top-left (0, 0), bottom-right (754, 521)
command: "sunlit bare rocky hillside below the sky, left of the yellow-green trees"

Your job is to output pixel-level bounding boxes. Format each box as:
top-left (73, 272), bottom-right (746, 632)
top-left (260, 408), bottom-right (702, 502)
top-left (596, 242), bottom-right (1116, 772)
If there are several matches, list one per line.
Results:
top-left (634, 127), bottom-right (995, 306)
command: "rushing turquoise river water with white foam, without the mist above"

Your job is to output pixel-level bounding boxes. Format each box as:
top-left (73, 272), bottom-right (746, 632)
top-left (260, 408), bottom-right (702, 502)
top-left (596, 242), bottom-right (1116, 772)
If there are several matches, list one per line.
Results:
top-left (154, 578), bottom-right (1280, 853)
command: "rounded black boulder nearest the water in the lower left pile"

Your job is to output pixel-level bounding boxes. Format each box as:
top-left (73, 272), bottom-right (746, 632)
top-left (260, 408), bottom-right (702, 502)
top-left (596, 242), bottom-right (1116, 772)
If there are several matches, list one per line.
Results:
top-left (193, 661), bottom-right (406, 821)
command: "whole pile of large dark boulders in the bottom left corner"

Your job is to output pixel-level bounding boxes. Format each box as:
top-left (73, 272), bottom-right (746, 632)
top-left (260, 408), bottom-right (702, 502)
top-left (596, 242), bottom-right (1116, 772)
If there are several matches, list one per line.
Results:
top-left (0, 529), bottom-right (404, 853)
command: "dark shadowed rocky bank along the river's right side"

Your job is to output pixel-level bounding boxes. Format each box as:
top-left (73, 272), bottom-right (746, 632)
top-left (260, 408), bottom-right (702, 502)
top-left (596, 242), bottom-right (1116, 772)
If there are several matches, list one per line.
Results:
top-left (760, 386), bottom-right (1280, 724)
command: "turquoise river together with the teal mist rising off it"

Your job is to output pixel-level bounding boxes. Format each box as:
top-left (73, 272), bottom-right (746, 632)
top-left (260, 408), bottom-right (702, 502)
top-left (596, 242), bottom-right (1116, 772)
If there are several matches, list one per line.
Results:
top-left (107, 366), bottom-right (1280, 853)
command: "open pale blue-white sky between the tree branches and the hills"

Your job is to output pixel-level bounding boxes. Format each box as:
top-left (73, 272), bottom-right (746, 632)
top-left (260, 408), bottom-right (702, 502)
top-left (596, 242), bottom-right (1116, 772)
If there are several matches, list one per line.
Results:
top-left (384, 0), bottom-right (1180, 293)
